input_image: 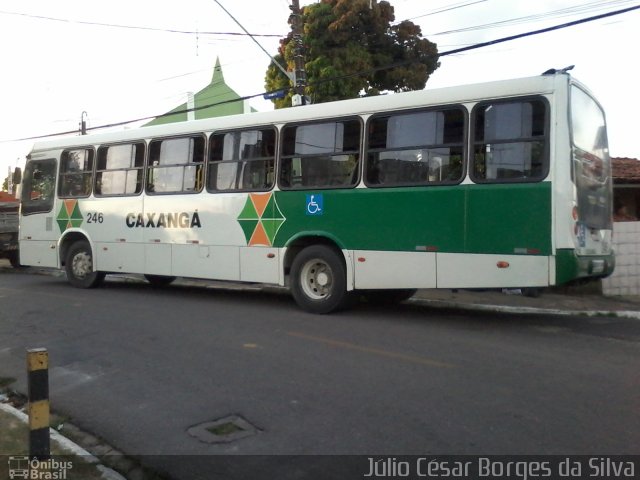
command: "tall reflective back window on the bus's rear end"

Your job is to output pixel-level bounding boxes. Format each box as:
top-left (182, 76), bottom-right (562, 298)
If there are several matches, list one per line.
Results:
top-left (571, 85), bottom-right (613, 229)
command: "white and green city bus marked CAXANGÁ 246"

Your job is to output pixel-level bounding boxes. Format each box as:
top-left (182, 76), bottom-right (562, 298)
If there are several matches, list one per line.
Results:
top-left (20, 72), bottom-right (614, 313)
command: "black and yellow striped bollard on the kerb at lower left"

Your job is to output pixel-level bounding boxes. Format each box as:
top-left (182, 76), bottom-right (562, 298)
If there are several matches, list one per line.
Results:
top-left (27, 348), bottom-right (50, 459)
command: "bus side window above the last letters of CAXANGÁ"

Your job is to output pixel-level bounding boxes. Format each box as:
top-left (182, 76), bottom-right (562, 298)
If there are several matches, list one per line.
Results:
top-left (147, 136), bottom-right (205, 194)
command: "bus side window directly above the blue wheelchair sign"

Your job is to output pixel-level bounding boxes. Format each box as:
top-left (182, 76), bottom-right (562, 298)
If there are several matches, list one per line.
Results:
top-left (280, 119), bottom-right (362, 189)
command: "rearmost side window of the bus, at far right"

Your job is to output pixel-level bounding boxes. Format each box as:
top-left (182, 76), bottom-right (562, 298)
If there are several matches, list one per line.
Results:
top-left (471, 100), bottom-right (549, 182)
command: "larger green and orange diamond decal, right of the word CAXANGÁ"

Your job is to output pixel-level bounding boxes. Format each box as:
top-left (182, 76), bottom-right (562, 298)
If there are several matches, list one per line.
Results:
top-left (238, 193), bottom-right (286, 247)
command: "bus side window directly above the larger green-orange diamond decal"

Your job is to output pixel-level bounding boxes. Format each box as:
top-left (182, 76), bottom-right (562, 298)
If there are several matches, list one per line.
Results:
top-left (207, 128), bottom-right (276, 192)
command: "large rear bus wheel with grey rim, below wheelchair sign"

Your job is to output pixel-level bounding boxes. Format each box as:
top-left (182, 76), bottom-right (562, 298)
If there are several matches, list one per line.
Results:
top-left (291, 245), bottom-right (348, 314)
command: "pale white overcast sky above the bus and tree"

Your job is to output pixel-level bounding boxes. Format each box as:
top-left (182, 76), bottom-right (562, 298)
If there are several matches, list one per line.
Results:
top-left (0, 0), bottom-right (640, 179)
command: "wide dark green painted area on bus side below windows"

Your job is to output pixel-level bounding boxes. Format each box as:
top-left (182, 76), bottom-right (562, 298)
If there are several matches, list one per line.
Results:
top-left (274, 182), bottom-right (551, 255)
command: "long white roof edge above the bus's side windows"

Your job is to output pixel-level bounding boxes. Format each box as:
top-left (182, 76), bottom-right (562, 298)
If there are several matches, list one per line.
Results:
top-left (27, 73), bottom-right (578, 153)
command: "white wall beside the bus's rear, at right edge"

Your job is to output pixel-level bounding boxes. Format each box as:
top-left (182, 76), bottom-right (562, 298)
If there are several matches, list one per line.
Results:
top-left (602, 222), bottom-right (640, 295)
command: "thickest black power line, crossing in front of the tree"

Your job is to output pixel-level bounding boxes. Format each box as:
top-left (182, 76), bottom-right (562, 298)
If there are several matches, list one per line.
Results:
top-left (0, 5), bottom-right (640, 143)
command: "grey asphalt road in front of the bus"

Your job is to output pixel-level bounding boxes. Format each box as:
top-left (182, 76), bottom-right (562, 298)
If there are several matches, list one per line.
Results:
top-left (0, 270), bottom-right (640, 479)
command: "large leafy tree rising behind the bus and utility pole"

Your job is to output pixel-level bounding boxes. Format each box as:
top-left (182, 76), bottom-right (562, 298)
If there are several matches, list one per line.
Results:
top-left (265, 0), bottom-right (440, 108)
